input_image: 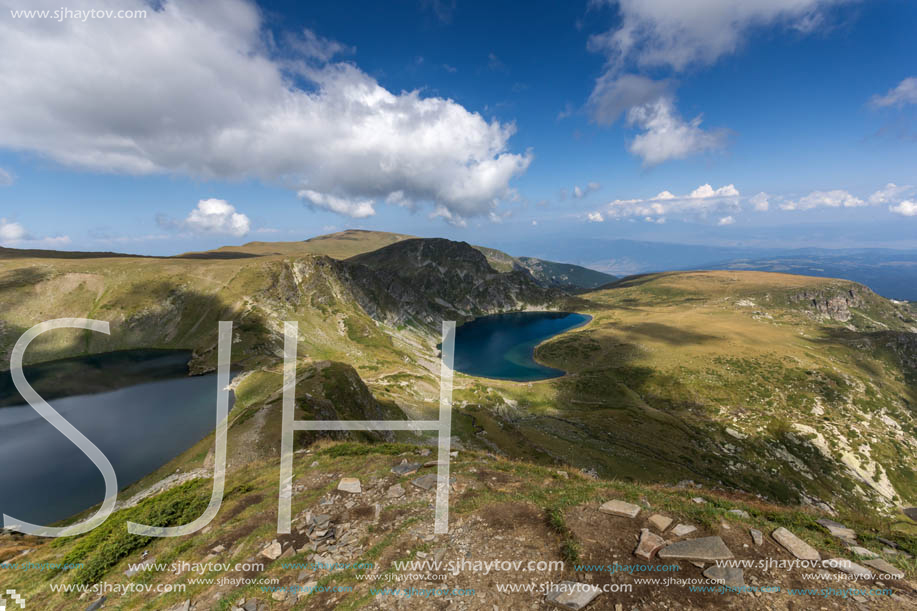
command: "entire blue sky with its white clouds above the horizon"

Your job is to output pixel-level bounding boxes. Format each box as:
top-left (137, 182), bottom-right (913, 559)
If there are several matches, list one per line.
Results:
top-left (0, 0), bottom-right (917, 260)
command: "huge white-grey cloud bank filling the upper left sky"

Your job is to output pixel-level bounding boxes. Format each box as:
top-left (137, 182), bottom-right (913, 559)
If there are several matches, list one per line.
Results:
top-left (0, 0), bottom-right (532, 224)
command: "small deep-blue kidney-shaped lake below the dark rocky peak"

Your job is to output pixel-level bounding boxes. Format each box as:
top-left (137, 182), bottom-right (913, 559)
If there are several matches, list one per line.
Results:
top-left (455, 312), bottom-right (592, 382)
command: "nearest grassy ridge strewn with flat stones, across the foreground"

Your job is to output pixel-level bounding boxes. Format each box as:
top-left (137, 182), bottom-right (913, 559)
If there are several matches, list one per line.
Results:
top-left (0, 359), bottom-right (917, 611)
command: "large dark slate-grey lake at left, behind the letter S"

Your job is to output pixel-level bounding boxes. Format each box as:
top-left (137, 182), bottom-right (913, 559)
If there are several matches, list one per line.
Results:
top-left (0, 351), bottom-right (232, 524)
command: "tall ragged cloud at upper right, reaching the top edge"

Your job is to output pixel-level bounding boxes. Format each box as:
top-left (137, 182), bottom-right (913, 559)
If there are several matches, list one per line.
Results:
top-left (587, 0), bottom-right (856, 165)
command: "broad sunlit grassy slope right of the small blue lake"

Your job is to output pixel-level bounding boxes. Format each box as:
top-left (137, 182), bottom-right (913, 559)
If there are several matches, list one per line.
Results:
top-left (458, 272), bottom-right (917, 510)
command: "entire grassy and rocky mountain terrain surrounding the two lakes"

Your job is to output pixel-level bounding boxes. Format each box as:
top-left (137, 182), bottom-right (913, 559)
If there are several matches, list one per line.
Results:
top-left (0, 240), bottom-right (917, 610)
